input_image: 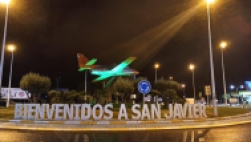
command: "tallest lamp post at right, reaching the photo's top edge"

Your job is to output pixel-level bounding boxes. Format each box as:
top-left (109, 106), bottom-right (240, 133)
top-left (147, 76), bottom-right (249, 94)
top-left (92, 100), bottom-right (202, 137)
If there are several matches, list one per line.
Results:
top-left (206, 0), bottom-right (218, 116)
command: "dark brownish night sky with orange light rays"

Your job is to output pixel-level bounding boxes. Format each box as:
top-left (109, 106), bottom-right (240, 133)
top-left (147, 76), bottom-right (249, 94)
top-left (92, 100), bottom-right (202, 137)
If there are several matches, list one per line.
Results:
top-left (0, 0), bottom-right (251, 96)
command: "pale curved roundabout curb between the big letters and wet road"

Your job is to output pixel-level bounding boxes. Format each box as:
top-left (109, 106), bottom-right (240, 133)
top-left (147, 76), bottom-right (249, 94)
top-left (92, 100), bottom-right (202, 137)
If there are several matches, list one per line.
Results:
top-left (0, 112), bottom-right (251, 131)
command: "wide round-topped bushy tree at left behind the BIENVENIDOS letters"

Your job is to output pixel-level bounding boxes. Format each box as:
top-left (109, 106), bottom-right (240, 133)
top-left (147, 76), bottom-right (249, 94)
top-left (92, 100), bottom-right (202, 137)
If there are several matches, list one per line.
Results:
top-left (20, 72), bottom-right (51, 102)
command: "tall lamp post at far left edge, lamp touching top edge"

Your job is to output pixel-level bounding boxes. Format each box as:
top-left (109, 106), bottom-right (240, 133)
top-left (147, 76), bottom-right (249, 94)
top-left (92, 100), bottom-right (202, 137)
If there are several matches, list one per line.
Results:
top-left (0, 0), bottom-right (10, 95)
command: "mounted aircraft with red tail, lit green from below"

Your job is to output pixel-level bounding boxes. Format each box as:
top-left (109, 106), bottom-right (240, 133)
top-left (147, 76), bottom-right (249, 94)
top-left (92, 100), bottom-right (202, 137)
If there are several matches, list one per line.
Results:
top-left (77, 53), bottom-right (139, 81)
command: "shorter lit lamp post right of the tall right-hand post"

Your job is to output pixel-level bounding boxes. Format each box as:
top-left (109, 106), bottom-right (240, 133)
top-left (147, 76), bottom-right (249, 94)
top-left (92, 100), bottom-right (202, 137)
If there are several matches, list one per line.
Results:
top-left (220, 41), bottom-right (227, 105)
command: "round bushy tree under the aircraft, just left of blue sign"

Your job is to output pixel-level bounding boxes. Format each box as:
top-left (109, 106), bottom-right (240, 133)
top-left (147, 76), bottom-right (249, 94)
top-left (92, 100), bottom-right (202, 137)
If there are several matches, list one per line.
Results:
top-left (112, 77), bottom-right (134, 103)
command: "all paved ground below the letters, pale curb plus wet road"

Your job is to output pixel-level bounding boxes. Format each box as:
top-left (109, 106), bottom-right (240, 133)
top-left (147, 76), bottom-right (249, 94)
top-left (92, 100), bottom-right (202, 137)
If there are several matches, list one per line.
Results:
top-left (0, 104), bottom-right (251, 142)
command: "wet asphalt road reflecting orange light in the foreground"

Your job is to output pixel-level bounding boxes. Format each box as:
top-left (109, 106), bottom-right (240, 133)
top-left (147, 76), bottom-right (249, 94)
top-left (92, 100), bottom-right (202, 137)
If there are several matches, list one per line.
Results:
top-left (0, 124), bottom-right (251, 142)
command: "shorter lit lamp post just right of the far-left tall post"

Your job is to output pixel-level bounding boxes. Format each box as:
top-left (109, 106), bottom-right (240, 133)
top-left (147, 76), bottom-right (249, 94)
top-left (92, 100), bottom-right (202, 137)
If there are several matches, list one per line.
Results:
top-left (6, 45), bottom-right (15, 107)
